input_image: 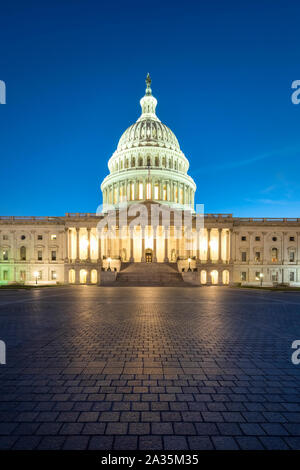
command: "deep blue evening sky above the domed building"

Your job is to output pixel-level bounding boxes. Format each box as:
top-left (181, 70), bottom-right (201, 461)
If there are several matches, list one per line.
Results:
top-left (0, 0), bottom-right (300, 217)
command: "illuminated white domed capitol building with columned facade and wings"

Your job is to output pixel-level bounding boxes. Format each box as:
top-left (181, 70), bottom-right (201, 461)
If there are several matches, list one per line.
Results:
top-left (0, 74), bottom-right (300, 287)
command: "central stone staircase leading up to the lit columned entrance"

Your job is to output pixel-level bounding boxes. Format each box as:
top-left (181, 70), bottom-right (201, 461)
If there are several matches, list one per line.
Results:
top-left (113, 263), bottom-right (187, 287)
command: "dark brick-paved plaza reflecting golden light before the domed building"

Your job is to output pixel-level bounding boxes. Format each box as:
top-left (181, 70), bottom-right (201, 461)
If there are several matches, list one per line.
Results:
top-left (0, 286), bottom-right (300, 450)
